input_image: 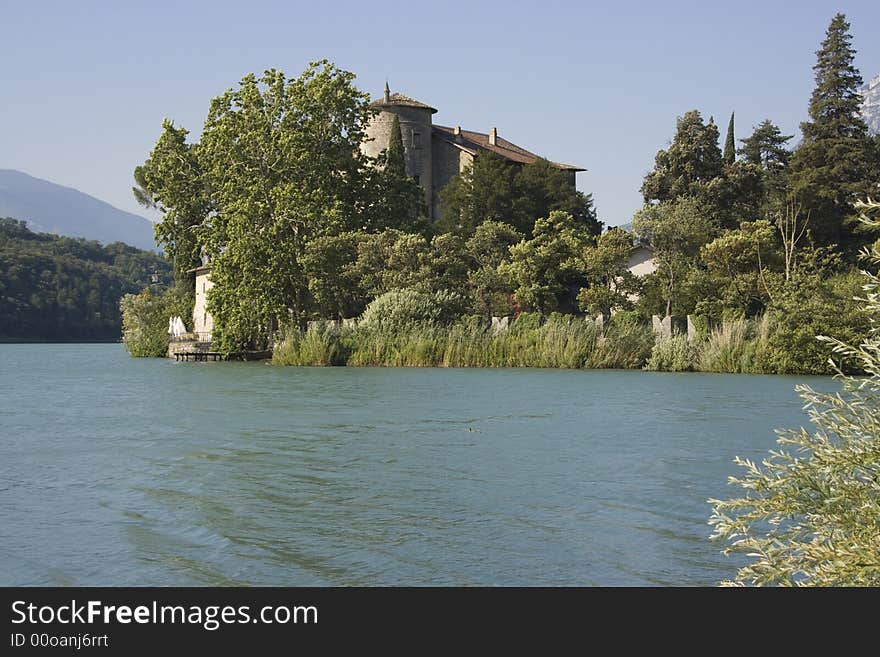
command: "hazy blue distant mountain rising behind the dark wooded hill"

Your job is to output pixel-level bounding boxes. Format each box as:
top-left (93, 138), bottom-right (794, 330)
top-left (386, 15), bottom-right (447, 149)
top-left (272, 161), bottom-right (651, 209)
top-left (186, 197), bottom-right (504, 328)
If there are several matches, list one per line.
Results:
top-left (0, 169), bottom-right (156, 249)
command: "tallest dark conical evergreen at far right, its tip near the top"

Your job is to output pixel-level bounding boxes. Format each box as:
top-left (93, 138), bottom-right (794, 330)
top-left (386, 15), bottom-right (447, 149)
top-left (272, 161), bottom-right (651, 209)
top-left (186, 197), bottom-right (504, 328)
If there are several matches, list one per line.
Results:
top-left (790, 14), bottom-right (870, 250)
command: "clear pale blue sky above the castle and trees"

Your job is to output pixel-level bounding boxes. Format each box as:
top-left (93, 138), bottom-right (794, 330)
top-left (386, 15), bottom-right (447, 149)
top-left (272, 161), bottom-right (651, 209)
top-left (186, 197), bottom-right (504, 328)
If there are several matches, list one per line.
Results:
top-left (0, 0), bottom-right (880, 225)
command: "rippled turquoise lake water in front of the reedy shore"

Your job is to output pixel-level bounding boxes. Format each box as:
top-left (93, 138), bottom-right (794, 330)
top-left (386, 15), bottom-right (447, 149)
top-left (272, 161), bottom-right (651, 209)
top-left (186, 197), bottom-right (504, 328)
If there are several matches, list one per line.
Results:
top-left (0, 344), bottom-right (835, 585)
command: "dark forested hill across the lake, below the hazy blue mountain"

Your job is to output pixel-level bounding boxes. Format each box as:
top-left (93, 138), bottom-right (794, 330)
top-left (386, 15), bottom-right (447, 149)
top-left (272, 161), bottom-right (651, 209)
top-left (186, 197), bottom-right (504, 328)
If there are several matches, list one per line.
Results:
top-left (0, 218), bottom-right (171, 342)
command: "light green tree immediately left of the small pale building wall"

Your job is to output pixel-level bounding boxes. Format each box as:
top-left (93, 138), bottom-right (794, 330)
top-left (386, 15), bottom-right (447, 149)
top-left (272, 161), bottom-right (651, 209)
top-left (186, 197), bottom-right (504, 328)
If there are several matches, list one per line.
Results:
top-left (578, 228), bottom-right (638, 315)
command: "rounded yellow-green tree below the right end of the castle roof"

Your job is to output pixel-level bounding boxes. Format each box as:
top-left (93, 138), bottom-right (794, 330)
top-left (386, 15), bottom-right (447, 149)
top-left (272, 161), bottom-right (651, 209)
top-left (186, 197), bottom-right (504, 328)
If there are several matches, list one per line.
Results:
top-left (499, 210), bottom-right (595, 313)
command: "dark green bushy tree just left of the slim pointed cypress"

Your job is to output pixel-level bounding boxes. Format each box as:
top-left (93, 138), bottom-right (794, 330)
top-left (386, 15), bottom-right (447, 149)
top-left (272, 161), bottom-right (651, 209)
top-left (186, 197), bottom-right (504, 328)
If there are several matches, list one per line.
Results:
top-left (641, 110), bottom-right (722, 203)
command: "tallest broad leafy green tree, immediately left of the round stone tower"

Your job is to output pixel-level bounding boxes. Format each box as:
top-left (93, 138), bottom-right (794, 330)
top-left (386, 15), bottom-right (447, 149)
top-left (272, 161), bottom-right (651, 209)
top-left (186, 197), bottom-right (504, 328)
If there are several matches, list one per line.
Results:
top-left (199, 61), bottom-right (373, 352)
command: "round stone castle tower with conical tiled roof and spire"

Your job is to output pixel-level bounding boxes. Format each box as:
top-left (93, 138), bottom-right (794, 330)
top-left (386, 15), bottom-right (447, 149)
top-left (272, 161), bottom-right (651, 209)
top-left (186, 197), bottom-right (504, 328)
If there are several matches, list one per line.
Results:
top-left (361, 82), bottom-right (437, 212)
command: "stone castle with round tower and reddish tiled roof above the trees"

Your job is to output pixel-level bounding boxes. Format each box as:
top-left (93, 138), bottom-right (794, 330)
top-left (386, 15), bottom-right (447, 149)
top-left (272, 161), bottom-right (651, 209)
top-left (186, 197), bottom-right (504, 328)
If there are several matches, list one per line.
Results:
top-left (361, 83), bottom-right (586, 219)
